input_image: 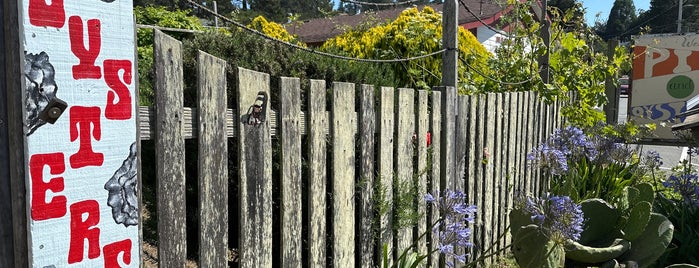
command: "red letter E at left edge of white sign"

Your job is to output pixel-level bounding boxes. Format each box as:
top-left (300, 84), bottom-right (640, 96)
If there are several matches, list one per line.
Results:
top-left (29, 153), bottom-right (67, 221)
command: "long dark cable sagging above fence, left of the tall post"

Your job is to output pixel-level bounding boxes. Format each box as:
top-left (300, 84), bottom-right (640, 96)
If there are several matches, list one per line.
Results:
top-left (180, 0), bottom-right (446, 63)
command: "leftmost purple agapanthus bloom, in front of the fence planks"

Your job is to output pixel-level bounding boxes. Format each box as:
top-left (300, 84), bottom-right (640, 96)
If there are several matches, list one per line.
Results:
top-left (425, 190), bottom-right (476, 267)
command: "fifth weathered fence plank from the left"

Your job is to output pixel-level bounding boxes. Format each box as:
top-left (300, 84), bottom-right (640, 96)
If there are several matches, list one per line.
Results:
top-left (307, 80), bottom-right (328, 268)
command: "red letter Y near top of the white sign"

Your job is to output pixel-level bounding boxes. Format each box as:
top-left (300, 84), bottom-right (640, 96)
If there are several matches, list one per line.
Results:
top-left (68, 16), bottom-right (102, 79)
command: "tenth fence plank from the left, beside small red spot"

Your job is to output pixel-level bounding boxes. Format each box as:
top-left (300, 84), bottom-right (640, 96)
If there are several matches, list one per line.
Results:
top-left (414, 90), bottom-right (431, 254)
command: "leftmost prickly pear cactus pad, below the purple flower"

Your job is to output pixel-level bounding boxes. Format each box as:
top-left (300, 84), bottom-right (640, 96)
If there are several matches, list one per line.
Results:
top-left (512, 224), bottom-right (565, 268)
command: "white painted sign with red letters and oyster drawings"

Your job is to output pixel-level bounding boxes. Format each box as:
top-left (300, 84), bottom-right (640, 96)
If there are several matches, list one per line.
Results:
top-left (22, 0), bottom-right (140, 267)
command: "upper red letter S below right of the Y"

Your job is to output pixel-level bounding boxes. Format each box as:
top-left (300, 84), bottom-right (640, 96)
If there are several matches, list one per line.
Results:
top-left (104, 60), bottom-right (133, 120)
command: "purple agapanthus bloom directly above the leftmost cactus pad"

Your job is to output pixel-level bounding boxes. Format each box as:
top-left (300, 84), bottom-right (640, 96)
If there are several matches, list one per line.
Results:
top-left (523, 194), bottom-right (584, 242)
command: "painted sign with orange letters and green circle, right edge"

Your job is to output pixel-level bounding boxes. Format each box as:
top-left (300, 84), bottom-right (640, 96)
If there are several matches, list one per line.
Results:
top-left (628, 34), bottom-right (699, 141)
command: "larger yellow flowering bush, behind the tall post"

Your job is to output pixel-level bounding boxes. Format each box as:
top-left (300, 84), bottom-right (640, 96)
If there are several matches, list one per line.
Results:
top-left (321, 7), bottom-right (491, 91)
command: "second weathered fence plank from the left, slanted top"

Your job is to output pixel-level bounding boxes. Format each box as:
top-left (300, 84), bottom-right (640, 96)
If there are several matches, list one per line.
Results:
top-left (197, 51), bottom-right (228, 267)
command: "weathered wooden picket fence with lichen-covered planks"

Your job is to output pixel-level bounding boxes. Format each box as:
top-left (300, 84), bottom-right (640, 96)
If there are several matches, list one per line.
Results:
top-left (140, 30), bottom-right (561, 267)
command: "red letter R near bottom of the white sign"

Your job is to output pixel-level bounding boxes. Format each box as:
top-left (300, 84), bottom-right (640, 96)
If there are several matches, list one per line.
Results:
top-left (68, 200), bottom-right (100, 264)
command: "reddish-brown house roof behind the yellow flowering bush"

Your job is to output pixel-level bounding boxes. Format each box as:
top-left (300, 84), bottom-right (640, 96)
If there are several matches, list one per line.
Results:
top-left (284, 0), bottom-right (536, 44)
